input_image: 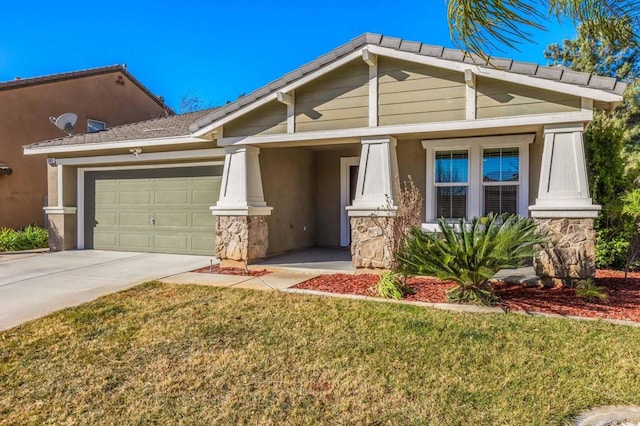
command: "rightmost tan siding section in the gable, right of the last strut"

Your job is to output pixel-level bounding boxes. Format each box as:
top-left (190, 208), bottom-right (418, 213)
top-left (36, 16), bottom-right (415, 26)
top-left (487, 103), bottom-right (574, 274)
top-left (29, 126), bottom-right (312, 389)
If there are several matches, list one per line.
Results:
top-left (476, 77), bottom-right (581, 118)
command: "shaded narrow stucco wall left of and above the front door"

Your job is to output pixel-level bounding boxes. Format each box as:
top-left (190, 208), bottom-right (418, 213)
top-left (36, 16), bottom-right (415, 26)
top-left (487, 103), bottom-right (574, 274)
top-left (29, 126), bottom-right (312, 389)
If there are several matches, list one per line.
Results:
top-left (316, 144), bottom-right (361, 247)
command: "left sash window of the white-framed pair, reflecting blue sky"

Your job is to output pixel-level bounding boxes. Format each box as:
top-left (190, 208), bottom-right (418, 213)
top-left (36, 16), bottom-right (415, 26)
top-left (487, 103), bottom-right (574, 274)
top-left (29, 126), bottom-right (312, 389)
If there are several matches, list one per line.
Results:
top-left (434, 150), bottom-right (469, 219)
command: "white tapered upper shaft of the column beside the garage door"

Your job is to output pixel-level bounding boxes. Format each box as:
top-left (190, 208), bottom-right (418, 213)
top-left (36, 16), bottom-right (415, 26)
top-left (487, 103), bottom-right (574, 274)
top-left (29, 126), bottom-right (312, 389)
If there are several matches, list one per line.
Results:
top-left (211, 146), bottom-right (272, 216)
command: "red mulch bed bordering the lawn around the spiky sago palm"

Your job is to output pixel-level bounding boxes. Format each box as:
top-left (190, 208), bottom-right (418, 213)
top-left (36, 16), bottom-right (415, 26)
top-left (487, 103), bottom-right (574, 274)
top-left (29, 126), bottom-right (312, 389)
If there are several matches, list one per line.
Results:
top-left (295, 270), bottom-right (640, 322)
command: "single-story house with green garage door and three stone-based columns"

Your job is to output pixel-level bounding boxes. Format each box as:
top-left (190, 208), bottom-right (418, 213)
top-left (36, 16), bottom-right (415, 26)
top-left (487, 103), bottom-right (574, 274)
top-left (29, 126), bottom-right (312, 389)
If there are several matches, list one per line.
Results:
top-left (25, 33), bottom-right (625, 278)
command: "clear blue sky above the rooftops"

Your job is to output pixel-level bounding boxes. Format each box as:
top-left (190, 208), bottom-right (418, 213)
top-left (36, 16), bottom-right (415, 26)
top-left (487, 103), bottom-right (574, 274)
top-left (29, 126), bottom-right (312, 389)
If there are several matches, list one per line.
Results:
top-left (0, 0), bottom-right (575, 108)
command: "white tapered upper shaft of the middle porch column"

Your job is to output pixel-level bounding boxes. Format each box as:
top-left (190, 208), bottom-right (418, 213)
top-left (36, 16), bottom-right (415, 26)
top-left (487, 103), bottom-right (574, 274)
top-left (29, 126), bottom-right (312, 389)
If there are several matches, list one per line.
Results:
top-left (347, 136), bottom-right (398, 216)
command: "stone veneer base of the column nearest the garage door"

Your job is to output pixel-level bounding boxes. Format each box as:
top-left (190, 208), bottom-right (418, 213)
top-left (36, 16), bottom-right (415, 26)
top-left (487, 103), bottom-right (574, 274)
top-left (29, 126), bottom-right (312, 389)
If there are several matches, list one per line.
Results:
top-left (216, 216), bottom-right (269, 261)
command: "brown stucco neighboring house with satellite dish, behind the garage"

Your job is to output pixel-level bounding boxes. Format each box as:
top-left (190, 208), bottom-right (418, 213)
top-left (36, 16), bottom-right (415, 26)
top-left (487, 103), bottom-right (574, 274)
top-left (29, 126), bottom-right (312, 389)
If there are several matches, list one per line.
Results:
top-left (0, 65), bottom-right (173, 228)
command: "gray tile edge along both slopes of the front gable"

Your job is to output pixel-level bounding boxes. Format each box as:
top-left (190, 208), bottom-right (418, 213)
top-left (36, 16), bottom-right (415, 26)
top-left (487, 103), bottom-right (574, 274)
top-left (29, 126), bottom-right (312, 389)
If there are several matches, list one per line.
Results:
top-left (189, 33), bottom-right (626, 132)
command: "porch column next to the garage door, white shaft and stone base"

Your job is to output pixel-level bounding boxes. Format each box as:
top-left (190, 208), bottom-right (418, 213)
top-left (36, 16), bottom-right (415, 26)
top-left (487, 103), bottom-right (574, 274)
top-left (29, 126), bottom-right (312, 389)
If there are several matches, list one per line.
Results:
top-left (211, 146), bottom-right (272, 263)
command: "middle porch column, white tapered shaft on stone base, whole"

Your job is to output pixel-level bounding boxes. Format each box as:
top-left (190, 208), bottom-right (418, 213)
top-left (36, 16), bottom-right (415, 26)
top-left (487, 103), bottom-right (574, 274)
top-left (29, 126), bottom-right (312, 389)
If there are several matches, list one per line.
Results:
top-left (347, 136), bottom-right (398, 268)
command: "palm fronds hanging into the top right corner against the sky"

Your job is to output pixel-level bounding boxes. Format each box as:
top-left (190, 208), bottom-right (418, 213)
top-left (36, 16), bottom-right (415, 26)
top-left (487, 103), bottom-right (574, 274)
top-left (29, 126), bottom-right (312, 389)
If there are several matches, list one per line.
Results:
top-left (447, 0), bottom-right (640, 56)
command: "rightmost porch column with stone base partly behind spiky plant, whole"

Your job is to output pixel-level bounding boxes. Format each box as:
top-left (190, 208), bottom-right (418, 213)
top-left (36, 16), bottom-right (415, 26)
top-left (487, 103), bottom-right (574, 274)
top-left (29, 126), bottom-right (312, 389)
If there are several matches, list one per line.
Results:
top-left (529, 123), bottom-right (600, 284)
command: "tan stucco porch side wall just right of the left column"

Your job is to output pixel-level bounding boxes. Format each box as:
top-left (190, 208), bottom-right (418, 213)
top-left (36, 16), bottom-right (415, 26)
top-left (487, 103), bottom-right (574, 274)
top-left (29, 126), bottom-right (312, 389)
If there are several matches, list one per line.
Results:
top-left (260, 148), bottom-right (316, 255)
